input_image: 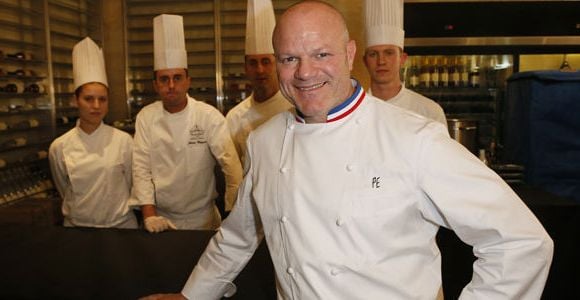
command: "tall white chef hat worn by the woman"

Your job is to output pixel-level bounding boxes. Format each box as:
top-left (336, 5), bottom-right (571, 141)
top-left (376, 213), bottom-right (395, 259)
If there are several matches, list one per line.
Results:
top-left (73, 37), bottom-right (109, 90)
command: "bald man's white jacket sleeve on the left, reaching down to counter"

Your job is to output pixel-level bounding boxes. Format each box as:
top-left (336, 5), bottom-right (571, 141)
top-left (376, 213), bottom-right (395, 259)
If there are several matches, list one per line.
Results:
top-left (181, 142), bottom-right (264, 299)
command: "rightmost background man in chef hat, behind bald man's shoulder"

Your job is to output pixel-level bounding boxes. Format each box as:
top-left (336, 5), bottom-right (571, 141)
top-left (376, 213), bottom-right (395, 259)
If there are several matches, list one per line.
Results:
top-left (363, 0), bottom-right (447, 126)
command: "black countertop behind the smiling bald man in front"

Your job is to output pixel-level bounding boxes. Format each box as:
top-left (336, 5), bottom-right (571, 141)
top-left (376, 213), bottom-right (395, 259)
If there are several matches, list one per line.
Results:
top-left (0, 185), bottom-right (580, 300)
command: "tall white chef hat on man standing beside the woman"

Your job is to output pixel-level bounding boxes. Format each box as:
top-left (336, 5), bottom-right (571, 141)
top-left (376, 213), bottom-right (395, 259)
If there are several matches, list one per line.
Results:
top-left (153, 14), bottom-right (187, 71)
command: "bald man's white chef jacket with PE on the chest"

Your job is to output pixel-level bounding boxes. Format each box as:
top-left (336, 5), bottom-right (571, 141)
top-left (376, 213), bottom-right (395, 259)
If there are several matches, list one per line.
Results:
top-left (182, 82), bottom-right (553, 300)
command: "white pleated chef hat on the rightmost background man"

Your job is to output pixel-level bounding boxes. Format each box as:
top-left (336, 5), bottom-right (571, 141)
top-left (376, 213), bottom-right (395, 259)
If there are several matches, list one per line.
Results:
top-left (365, 0), bottom-right (405, 49)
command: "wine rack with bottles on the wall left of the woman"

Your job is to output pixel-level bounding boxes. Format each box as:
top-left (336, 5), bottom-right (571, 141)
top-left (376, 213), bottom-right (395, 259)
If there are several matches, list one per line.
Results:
top-left (0, 0), bottom-right (100, 207)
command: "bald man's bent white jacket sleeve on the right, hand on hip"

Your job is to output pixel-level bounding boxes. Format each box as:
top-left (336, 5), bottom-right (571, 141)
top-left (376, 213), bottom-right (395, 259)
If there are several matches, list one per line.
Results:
top-left (416, 126), bottom-right (553, 299)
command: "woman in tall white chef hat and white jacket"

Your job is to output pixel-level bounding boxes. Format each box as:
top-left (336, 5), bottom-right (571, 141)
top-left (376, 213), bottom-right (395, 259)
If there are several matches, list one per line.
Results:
top-left (49, 37), bottom-right (137, 228)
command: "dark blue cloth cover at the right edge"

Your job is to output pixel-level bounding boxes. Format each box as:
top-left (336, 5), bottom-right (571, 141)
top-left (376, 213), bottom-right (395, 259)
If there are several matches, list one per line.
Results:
top-left (504, 71), bottom-right (580, 202)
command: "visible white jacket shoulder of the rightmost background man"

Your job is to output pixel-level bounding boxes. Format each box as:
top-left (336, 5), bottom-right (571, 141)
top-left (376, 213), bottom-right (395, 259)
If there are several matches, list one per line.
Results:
top-left (368, 86), bottom-right (447, 127)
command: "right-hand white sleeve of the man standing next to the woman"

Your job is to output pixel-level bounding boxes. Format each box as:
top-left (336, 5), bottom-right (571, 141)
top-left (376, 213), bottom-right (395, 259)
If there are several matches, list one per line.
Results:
top-left (208, 111), bottom-right (242, 211)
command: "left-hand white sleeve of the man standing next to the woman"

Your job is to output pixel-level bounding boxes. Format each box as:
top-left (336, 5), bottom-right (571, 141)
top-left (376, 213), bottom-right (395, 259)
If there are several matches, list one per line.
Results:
top-left (129, 113), bottom-right (155, 206)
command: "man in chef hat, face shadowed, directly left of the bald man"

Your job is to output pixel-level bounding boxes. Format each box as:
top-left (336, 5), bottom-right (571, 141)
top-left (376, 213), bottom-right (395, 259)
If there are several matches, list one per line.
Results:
top-left (226, 0), bottom-right (292, 162)
